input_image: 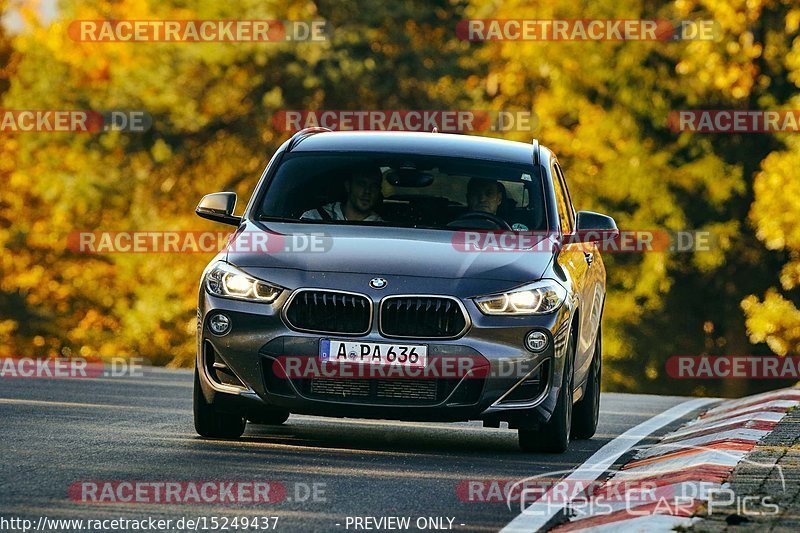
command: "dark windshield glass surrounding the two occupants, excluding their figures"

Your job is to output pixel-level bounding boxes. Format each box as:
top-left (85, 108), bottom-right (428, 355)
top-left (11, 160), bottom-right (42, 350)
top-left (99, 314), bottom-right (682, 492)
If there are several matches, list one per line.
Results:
top-left (257, 152), bottom-right (546, 231)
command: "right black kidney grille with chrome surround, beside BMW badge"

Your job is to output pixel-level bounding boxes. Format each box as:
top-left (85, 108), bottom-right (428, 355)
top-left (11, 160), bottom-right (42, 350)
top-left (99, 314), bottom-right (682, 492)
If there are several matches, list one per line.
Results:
top-left (381, 296), bottom-right (467, 338)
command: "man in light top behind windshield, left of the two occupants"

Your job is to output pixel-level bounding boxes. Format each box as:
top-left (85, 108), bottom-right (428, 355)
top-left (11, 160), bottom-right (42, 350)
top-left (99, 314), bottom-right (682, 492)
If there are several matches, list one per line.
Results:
top-left (300, 167), bottom-right (383, 222)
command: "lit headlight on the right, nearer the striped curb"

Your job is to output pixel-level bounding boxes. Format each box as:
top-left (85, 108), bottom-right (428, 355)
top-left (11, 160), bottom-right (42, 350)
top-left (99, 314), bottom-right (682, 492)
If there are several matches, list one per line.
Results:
top-left (475, 279), bottom-right (567, 315)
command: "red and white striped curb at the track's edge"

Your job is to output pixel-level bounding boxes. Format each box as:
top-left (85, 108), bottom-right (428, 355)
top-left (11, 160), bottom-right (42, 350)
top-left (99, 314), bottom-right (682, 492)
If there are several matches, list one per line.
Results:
top-left (552, 388), bottom-right (800, 533)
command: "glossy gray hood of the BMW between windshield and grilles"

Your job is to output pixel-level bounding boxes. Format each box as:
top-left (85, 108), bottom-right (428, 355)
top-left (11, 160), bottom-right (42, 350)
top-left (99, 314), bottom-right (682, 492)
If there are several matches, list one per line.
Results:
top-left (227, 222), bottom-right (552, 283)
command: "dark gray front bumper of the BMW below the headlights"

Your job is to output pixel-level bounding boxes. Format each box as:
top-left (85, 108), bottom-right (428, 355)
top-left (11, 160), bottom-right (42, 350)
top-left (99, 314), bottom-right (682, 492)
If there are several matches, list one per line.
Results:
top-left (197, 282), bottom-right (570, 427)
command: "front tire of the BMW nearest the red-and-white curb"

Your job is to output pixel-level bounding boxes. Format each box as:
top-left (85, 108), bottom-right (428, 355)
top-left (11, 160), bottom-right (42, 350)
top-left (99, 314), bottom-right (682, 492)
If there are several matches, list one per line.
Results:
top-left (519, 335), bottom-right (575, 453)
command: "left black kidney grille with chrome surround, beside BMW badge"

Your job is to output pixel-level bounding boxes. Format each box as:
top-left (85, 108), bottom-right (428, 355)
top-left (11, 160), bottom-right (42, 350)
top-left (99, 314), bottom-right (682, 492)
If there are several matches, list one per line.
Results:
top-left (286, 290), bottom-right (371, 334)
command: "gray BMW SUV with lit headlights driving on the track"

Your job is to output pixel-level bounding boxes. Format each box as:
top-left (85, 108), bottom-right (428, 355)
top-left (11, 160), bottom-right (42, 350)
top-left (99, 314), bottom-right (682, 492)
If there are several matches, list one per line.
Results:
top-left (194, 128), bottom-right (618, 452)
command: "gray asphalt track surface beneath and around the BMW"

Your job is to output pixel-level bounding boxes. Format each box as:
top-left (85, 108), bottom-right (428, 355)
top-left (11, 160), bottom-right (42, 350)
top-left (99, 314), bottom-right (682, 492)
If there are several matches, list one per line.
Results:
top-left (0, 369), bottom-right (708, 531)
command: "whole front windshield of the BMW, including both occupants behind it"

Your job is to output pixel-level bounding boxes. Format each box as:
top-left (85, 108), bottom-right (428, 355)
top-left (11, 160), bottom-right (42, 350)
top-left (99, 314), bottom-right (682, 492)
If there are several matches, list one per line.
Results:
top-left (256, 152), bottom-right (547, 231)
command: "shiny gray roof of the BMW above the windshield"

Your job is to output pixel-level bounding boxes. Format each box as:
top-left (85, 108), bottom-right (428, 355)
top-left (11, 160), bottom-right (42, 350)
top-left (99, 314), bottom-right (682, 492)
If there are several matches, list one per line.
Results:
top-left (290, 131), bottom-right (549, 164)
